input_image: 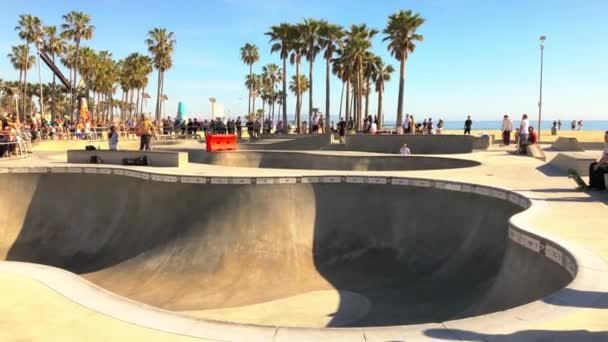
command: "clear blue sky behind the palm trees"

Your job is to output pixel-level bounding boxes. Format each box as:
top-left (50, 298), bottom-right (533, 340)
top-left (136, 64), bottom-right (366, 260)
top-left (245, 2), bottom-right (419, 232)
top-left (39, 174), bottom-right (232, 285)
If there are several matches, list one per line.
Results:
top-left (0, 0), bottom-right (608, 120)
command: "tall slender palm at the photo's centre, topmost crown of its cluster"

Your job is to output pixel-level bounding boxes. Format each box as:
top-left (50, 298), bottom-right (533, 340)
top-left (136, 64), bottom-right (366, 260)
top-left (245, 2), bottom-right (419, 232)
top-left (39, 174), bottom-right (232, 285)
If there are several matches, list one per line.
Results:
top-left (299, 18), bottom-right (327, 131)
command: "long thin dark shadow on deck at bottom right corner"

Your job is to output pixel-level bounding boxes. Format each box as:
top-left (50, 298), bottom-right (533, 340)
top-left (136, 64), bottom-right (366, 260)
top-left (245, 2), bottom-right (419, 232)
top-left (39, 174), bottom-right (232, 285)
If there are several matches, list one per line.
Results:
top-left (424, 329), bottom-right (608, 342)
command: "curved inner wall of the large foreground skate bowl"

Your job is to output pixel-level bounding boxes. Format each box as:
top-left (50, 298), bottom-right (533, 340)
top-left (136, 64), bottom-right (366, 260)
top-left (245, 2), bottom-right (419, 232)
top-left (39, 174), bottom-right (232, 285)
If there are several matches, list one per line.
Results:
top-left (0, 173), bottom-right (571, 327)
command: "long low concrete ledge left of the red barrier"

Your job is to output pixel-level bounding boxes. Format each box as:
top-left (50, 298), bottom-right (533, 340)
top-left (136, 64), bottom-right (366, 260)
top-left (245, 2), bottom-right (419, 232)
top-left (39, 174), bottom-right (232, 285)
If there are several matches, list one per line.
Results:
top-left (68, 150), bottom-right (188, 167)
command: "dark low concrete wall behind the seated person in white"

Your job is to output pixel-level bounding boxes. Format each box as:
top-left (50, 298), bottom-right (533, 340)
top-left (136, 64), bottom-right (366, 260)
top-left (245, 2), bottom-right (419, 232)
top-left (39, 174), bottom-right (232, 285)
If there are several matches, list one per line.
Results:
top-left (346, 134), bottom-right (476, 154)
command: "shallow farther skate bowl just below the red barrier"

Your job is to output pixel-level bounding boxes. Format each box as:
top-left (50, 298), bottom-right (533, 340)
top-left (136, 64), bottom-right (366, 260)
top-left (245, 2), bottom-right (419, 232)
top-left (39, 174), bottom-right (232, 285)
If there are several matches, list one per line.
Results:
top-left (189, 150), bottom-right (480, 171)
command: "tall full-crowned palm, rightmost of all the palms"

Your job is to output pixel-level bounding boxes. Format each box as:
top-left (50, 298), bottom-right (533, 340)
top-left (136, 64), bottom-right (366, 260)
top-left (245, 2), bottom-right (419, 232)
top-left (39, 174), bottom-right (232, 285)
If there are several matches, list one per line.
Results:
top-left (383, 10), bottom-right (425, 129)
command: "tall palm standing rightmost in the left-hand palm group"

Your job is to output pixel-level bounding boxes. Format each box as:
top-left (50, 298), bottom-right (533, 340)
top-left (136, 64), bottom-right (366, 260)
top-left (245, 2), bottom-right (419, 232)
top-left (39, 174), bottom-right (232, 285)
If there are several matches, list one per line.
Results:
top-left (146, 28), bottom-right (175, 121)
